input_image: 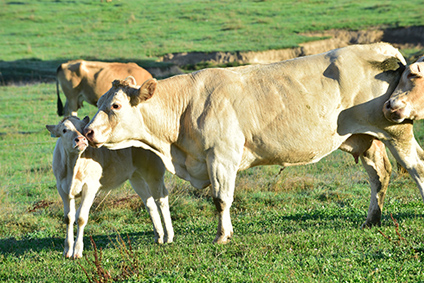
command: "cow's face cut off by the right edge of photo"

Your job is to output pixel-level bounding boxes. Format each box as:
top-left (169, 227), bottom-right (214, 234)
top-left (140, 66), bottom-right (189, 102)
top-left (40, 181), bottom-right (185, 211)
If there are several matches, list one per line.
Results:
top-left (383, 57), bottom-right (424, 123)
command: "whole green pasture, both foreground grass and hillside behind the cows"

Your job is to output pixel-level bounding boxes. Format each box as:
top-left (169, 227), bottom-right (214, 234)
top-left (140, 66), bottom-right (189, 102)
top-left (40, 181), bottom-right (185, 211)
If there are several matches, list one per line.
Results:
top-left (0, 0), bottom-right (424, 282)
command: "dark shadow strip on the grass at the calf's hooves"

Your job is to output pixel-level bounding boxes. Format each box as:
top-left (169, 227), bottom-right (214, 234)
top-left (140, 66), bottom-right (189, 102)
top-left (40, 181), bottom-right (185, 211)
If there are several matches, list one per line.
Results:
top-left (0, 231), bottom-right (155, 257)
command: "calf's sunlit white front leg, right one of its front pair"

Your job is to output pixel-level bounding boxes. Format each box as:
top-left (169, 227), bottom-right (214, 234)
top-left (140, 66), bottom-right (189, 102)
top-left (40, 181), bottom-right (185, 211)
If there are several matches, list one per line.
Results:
top-left (73, 184), bottom-right (100, 259)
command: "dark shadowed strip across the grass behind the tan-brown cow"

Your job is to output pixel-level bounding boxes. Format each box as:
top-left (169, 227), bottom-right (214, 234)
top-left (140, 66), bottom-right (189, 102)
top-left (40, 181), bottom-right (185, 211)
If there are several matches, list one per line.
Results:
top-left (0, 58), bottom-right (179, 85)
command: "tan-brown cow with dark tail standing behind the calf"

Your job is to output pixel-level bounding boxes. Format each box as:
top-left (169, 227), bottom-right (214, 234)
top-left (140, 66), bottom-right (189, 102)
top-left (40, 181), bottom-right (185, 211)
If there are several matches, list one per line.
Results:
top-left (56, 60), bottom-right (152, 116)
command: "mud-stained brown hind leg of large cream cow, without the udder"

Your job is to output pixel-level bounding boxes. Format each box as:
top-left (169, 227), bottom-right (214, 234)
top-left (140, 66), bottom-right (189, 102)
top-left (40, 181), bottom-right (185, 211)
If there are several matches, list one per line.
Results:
top-left (360, 139), bottom-right (392, 228)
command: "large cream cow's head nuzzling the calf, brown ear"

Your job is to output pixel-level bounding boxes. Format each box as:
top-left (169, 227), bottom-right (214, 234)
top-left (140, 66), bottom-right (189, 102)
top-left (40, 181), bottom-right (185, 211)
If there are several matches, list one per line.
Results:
top-left (84, 77), bottom-right (157, 149)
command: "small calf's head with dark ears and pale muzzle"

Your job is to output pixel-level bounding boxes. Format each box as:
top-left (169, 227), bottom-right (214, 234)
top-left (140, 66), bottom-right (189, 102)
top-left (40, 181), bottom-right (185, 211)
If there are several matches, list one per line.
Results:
top-left (46, 116), bottom-right (90, 154)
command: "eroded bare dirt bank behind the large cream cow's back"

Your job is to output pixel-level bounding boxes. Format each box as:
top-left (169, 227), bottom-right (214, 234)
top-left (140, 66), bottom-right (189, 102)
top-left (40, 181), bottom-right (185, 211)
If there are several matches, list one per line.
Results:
top-left (160, 26), bottom-right (424, 66)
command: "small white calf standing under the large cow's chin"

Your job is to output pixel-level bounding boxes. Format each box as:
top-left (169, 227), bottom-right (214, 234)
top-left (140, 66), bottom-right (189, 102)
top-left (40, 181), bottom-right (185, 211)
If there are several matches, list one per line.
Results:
top-left (46, 116), bottom-right (174, 258)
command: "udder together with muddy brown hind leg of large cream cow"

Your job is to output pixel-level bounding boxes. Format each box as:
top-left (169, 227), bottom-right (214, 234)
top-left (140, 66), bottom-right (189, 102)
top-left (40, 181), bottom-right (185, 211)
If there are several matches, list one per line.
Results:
top-left (340, 135), bottom-right (392, 228)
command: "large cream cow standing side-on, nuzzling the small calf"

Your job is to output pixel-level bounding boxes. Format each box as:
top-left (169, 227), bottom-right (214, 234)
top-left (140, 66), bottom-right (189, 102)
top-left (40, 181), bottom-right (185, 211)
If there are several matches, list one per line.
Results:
top-left (84, 43), bottom-right (424, 243)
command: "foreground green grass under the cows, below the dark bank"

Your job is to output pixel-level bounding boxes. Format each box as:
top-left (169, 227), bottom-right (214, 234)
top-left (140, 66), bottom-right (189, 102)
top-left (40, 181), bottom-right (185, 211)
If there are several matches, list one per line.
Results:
top-left (0, 84), bottom-right (424, 282)
